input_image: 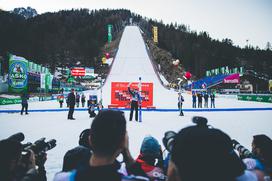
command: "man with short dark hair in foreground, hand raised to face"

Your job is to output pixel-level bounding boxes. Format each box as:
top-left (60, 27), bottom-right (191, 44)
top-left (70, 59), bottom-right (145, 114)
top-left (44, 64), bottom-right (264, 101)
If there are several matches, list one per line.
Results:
top-left (54, 110), bottom-right (147, 181)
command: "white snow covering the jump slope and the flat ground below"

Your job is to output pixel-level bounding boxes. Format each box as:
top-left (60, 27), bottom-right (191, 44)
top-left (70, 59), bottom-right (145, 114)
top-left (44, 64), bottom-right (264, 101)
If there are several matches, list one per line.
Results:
top-left (0, 26), bottom-right (272, 180)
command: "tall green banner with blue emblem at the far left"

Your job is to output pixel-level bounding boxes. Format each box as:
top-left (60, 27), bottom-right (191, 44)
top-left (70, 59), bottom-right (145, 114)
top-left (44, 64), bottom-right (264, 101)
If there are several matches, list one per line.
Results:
top-left (8, 55), bottom-right (28, 93)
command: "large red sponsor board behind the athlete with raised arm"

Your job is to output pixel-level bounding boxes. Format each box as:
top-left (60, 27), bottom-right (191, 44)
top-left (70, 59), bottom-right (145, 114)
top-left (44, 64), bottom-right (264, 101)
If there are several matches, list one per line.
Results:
top-left (111, 82), bottom-right (153, 107)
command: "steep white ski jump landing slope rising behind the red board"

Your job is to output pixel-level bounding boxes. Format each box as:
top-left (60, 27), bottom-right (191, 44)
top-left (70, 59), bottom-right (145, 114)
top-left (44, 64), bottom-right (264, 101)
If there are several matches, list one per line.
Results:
top-left (102, 26), bottom-right (177, 108)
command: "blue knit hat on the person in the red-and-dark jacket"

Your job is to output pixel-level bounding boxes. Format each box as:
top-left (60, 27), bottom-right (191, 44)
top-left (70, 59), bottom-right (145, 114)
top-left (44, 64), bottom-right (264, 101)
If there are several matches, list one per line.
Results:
top-left (141, 136), bottom-right (161, 158)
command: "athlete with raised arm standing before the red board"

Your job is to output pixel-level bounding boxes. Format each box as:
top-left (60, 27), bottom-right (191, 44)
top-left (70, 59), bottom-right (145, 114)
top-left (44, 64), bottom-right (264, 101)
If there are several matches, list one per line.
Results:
top-left (128, 83), bottom-right (140, 121)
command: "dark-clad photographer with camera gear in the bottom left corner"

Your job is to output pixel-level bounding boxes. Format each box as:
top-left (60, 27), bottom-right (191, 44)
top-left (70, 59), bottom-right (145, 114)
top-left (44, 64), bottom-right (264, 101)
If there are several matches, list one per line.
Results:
top-left (0, 139), bottom-right (46, 181)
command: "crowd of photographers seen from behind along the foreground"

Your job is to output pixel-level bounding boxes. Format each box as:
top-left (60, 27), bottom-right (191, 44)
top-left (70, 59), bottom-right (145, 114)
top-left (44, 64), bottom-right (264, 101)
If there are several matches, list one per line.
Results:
top-left (0, 110), bottom-right (272, 181)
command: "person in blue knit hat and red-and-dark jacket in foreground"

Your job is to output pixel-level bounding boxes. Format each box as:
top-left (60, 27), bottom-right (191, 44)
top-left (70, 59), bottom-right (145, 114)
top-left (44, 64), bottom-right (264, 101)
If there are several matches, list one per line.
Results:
top-left (128, 136), bottom-right (166, 180)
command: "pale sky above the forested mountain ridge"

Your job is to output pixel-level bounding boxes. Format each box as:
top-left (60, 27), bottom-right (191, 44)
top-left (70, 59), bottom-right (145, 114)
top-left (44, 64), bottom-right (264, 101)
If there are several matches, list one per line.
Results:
top-left (0, 0), bottom-right (272, 49)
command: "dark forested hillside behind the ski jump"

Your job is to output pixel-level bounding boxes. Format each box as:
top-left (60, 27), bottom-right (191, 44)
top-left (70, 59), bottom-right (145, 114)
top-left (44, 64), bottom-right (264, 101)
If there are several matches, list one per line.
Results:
top-left (0, 9), bottom-right (272, 90)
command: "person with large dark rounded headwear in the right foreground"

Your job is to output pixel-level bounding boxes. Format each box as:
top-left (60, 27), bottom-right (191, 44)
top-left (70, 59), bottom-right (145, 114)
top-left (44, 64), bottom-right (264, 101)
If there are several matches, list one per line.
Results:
top-left (167, 123), bottom-right (258, 181)
